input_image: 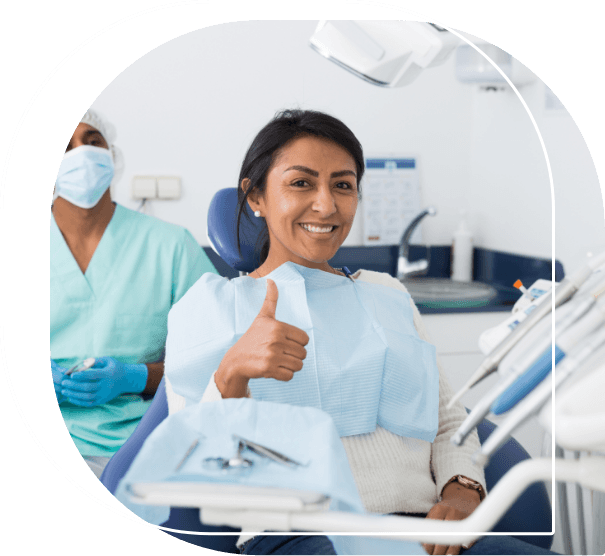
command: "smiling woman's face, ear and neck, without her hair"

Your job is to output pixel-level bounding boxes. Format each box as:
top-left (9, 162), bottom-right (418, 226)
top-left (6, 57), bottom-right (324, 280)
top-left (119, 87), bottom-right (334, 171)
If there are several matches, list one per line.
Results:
top-left (244, 137), bottom-right (358, 270)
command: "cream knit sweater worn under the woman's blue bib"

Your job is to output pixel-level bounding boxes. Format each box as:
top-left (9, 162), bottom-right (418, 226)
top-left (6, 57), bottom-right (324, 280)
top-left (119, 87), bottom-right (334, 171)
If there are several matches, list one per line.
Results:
top-left (166, 270), bottom-right (486, 514)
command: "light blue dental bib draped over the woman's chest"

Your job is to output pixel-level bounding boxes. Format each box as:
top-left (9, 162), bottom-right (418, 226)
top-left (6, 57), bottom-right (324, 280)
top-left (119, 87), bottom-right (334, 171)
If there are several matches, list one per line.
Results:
top-left (166, 263), bottom-right (439, 442)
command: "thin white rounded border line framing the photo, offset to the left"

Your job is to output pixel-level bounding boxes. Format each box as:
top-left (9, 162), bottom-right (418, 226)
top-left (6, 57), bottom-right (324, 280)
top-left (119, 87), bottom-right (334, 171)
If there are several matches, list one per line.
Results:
top-left (0, 0), bottom-right (556, 537)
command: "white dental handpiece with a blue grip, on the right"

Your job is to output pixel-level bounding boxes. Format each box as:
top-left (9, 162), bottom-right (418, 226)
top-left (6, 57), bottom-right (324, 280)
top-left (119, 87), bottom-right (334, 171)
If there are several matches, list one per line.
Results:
top-left (450, 296), bottom-right (605, 446)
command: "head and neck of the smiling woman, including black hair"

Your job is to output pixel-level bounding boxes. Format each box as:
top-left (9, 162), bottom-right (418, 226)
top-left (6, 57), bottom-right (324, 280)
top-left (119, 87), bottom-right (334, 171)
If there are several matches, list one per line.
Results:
top-left (238, 110), bottom-right (365, 277)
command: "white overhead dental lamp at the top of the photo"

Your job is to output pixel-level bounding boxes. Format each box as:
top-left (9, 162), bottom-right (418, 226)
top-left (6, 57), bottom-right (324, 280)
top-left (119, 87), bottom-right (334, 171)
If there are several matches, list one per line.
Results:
top-left (310, 20), bottom-right (460, 87)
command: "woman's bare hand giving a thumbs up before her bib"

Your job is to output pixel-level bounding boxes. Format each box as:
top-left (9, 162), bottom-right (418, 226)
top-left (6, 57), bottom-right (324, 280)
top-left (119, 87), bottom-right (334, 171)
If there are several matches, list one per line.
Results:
top-left (214, 279), bottom-right (309, 398)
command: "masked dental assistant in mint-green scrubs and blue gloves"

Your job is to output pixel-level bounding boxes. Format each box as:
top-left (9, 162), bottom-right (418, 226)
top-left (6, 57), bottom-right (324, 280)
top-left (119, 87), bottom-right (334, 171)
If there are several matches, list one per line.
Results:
top-left (50, 110), bottom-right (216, 476)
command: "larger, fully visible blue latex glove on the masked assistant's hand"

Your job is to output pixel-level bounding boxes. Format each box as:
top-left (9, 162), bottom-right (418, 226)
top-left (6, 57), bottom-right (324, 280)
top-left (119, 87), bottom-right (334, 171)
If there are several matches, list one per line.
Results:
top-left (61, 357), bottom-right (148, 407)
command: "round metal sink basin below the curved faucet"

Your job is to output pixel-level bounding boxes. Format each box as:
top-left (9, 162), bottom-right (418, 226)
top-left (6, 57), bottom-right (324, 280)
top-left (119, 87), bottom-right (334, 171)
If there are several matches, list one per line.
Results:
top-left (402, 278), bottom-right (498, 309)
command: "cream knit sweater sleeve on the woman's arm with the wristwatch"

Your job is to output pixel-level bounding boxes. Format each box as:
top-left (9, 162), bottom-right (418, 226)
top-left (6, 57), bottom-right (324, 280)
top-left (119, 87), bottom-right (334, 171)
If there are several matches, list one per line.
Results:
top-left (357, 271), bottom-right (487, 494)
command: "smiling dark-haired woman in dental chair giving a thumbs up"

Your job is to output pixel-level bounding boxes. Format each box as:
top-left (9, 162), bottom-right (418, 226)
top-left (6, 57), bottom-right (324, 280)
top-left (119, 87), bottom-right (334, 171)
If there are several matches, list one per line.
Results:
top-left (166, 110), bottom-right (551, 554)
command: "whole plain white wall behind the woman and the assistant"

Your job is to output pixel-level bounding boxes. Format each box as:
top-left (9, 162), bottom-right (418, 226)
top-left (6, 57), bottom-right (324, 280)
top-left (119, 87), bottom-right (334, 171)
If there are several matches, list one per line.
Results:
top-left (93, 21), bottom-right (605, 274)
